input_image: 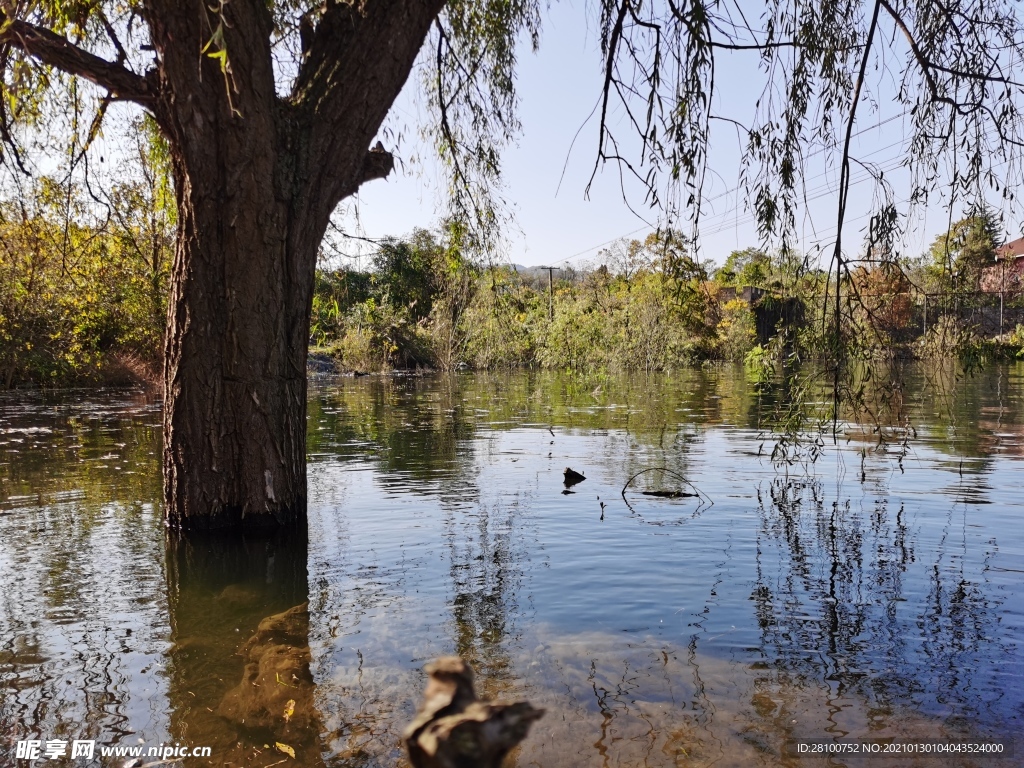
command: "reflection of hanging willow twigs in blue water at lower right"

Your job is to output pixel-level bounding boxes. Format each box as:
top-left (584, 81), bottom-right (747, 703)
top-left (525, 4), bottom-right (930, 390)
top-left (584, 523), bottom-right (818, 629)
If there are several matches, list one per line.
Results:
top-left (752, 478), bottom-right (1012, 753)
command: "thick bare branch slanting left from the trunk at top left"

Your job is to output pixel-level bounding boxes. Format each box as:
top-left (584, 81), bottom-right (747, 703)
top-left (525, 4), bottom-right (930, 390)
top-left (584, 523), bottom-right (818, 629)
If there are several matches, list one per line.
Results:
top-left (0, 12), bottom-right (157, 108)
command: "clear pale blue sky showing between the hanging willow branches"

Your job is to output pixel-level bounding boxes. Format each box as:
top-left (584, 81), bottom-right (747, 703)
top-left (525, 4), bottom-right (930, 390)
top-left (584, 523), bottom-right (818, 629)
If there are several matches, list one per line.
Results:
top-left (331, 0), bottom-right (1003, 274)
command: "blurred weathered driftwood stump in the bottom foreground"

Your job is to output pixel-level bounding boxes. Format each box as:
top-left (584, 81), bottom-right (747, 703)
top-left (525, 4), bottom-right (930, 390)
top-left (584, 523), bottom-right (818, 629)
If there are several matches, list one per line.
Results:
top-left (402, 656), bottom-right (544, 768)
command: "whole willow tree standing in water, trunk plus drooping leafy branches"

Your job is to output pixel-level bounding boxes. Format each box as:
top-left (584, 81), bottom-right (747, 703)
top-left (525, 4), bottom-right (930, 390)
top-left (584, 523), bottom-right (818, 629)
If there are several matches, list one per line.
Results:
top-left (0, 0), bottom-right (1024, 528)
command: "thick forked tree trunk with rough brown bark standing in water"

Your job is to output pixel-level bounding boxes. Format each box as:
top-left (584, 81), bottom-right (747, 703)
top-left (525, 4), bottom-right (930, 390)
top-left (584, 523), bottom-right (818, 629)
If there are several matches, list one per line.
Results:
top-left (144, 0), bottom-right (443, 529)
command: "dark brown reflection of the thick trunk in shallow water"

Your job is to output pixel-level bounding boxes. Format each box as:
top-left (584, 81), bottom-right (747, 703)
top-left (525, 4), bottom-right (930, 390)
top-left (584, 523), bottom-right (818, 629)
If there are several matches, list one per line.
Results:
top-left (167, 530), bottom-right (323, 768)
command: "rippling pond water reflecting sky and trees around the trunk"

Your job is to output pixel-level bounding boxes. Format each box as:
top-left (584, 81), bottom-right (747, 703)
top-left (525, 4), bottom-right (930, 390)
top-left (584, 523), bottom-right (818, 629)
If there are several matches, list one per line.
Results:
top-left (0, 365), bottom-right (1024, 768)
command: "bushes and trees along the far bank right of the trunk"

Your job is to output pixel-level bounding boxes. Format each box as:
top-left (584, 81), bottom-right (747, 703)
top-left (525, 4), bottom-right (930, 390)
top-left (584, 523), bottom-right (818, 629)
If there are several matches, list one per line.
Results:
top-left (312, 214), bottom-right (1024, 375)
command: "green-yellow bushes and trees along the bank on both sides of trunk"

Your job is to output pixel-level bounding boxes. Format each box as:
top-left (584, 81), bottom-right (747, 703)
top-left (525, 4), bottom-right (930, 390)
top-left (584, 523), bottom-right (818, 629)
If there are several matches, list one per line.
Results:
top-left (6, 207), bottom-right (1024, 388)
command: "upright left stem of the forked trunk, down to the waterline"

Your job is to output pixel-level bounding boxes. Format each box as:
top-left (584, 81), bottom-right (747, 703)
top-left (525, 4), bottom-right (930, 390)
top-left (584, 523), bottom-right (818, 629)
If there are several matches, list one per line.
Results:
top-left (151, 3), bottom-right (301, 528)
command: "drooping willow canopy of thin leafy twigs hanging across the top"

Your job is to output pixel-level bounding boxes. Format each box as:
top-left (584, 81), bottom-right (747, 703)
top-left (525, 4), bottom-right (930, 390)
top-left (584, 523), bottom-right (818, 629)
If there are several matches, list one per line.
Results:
top-left (0, 0), bottom-right (1024, 253)
